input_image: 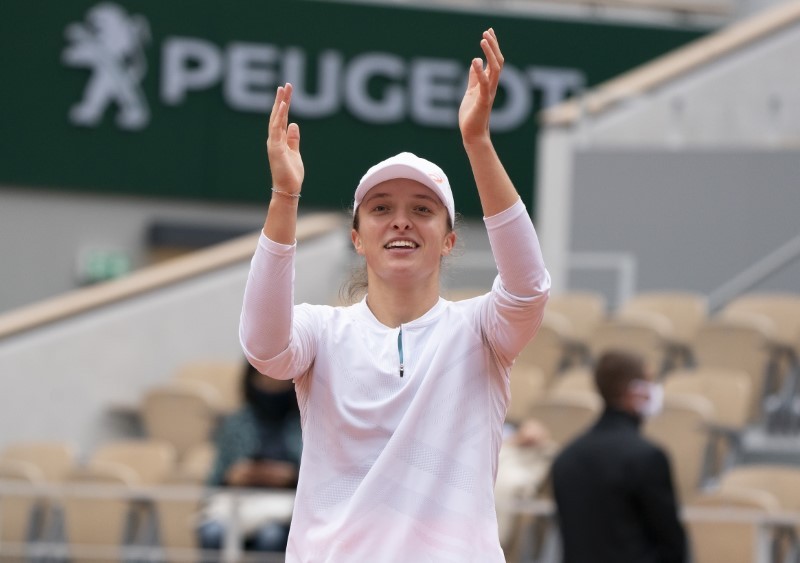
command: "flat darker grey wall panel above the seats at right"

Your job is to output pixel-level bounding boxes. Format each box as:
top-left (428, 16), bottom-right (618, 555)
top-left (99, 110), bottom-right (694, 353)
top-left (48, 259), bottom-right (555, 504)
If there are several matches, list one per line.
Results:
top-left (570, 149), bottom-right (800, 308)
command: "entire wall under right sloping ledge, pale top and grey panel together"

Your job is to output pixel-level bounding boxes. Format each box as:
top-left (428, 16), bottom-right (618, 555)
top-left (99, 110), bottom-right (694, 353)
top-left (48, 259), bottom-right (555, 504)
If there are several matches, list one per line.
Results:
top-left (537, 12), bottom-right (800, 296)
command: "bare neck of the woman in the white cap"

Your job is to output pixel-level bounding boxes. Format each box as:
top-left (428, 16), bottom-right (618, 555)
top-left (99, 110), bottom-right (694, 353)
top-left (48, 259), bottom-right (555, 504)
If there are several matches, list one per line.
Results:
top-left (367, 280), bottom-right (439, 328)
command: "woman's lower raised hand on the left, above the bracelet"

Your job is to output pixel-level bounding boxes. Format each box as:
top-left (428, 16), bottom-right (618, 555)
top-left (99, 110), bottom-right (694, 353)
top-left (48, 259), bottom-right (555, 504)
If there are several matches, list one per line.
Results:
top-left (267, 83), bottom-right (305, 194)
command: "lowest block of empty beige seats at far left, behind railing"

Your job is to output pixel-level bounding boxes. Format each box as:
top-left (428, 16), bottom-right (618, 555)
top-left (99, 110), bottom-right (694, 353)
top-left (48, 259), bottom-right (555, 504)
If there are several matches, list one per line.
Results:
top-left (0, 440), bottom-right (214, 562)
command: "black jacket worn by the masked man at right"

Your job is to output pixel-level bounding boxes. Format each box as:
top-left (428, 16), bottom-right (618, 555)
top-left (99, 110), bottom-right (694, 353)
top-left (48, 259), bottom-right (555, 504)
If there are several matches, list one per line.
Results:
top-left (552, 409), bottom-right (687, 563)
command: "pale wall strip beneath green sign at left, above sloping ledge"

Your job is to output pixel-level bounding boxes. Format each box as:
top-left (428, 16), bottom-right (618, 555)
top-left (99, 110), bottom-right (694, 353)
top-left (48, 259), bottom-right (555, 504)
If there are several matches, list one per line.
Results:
top-left (0, 188), bottom-right (268, 312)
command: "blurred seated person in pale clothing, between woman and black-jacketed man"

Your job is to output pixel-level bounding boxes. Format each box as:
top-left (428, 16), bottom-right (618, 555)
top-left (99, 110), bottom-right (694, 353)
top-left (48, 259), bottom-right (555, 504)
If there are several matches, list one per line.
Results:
top-left (494, 418), bottom-right (557, 550)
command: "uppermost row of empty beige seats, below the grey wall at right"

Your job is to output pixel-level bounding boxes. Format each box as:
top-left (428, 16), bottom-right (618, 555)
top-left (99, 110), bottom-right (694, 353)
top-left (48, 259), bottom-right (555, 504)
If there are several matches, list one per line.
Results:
top-left (506, 292), bottom-right (800, 432)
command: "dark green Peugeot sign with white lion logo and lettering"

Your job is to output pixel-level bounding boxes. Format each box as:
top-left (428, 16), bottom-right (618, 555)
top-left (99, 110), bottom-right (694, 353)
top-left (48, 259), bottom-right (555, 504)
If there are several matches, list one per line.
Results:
top-left (0, 0), bottom-right (700, 215)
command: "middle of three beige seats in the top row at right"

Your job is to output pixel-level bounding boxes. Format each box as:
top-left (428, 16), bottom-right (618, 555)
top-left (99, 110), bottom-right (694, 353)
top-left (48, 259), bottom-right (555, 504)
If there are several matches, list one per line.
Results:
top-left (617, 291), bottom-right (708, 366)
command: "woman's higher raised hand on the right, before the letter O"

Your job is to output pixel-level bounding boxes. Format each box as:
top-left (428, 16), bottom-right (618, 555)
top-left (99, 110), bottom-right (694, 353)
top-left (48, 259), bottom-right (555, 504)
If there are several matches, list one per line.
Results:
top-left (458, 28), bottom-right (503, 144)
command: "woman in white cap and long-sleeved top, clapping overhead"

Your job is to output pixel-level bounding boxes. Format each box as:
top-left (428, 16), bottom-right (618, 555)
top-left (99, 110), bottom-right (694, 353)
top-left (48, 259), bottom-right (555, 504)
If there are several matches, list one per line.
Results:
top-left (240, 29), bottom-right (550, 563)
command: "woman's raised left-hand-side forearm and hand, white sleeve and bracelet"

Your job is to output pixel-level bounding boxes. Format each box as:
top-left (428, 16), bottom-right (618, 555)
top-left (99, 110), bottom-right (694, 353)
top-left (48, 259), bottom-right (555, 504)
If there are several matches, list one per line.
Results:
top-left (239, 84), bottom-right (304, 372)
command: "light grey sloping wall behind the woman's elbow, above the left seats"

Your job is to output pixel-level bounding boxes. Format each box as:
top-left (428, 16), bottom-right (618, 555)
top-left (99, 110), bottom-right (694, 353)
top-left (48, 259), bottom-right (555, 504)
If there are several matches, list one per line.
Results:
top-left (0, 232), bottom-right (347, 455)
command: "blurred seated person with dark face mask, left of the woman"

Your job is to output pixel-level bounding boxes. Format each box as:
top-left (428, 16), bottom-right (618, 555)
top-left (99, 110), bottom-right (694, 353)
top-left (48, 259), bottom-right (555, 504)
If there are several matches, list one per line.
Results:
top-left (197, 363), bottom-right (302, 551)
